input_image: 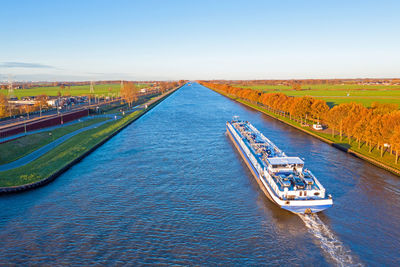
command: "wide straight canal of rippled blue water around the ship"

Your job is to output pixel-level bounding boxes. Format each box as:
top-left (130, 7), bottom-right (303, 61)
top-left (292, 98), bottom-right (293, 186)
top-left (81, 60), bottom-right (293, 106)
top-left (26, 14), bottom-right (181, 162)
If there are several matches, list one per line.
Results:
top-left (0, 84), bottom-right (400, 266)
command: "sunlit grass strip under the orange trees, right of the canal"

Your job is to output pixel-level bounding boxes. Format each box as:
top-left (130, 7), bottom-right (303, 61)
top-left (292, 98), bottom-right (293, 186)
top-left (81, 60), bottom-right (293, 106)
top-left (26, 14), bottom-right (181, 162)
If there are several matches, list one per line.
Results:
top-left (211, 87), bottom-right (400, 176)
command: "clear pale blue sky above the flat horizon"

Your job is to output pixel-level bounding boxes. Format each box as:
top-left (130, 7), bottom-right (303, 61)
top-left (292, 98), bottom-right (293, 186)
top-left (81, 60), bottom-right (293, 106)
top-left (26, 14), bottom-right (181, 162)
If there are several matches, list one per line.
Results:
top-left (0, 0), bottom-right (400, 80)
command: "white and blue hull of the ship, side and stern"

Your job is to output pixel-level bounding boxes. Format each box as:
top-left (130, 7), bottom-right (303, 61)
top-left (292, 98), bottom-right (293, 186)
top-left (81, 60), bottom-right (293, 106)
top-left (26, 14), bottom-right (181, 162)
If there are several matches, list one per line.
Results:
top-left (226, 124), bottom-right (333, 216)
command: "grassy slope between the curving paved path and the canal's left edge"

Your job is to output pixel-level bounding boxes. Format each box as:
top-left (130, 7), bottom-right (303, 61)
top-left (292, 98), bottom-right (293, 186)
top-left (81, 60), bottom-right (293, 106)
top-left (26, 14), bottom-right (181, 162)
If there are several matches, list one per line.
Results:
top-left (0, 88), bottom-right (177, 187)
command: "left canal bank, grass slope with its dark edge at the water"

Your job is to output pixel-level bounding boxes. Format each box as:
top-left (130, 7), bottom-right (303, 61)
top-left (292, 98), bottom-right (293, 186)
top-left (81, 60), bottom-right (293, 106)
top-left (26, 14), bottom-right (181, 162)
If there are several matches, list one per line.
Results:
top-left (0, 86), bottom-right (181, 194)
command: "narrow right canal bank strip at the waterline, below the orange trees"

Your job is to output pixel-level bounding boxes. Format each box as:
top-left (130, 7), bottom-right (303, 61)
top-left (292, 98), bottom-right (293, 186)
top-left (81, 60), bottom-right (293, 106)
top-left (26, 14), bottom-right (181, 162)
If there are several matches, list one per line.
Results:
top-left (203, 85), bottom-right (400, 179)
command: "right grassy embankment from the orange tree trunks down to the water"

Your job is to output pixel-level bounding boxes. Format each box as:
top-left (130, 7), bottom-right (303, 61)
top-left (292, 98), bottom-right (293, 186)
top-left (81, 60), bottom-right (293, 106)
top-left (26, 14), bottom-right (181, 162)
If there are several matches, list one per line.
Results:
top-left (211, 89), bottom-right (400, 175)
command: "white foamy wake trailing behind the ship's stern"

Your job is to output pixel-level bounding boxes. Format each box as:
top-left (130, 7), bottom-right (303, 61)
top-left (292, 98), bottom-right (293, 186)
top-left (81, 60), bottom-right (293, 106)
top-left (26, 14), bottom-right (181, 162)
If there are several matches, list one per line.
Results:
top-left (298, 214), bottom-right (363, 266)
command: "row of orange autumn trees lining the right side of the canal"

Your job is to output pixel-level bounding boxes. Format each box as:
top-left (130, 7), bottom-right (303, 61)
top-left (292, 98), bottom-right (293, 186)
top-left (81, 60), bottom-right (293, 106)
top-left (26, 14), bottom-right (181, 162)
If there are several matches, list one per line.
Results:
top-left (202, 82), bottom-right (400, 164)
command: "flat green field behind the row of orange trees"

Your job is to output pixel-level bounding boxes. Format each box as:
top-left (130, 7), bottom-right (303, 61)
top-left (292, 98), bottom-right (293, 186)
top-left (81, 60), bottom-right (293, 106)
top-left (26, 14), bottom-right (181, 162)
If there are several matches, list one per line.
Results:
top-left (232, 84), bottom-right (400, 107)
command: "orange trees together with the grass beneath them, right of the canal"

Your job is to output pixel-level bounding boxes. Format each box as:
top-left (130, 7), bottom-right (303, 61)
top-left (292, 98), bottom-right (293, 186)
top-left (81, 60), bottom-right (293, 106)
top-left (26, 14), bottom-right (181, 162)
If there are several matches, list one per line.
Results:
top-left (202, 82), bottom-right (400, 174)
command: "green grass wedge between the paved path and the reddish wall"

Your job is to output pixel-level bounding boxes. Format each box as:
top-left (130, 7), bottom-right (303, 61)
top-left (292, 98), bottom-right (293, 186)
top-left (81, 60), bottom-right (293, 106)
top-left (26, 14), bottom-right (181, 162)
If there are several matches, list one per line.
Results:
top-left (0, 118), bottom-right (106, 164)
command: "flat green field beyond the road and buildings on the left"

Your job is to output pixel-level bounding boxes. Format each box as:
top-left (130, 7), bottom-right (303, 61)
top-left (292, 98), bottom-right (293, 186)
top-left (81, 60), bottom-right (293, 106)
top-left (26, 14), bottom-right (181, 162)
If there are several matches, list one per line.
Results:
top-left (0, 84), bottom-right (149, 98)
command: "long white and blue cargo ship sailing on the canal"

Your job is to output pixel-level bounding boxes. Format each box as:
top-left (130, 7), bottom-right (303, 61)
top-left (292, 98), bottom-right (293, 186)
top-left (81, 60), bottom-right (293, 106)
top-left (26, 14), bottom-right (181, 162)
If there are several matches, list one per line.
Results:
top-left (226, 117), bottom-right (333, 213)
